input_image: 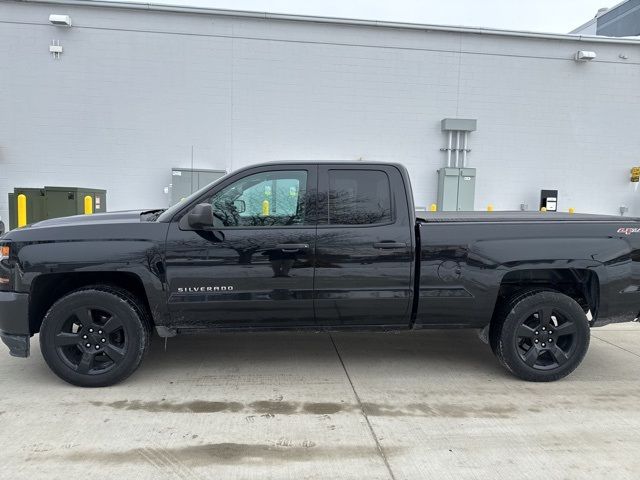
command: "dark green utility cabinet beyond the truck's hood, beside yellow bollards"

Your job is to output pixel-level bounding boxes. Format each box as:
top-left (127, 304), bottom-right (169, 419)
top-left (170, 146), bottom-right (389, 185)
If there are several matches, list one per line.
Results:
top-left (9, 186), bottom-right (107, 229)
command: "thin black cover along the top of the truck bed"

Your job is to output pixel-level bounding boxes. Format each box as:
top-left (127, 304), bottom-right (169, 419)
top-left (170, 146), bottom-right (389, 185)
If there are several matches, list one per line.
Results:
top-left (418, 211), bottom-right (640, 223)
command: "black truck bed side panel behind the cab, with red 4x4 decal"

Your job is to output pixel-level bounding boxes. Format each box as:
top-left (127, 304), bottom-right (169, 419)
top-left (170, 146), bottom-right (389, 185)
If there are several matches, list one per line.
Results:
top-left (414, 212), bottom-right (640, 328)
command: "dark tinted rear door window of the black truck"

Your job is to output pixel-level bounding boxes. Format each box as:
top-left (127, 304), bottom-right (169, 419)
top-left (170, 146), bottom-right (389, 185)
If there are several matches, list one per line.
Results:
top-left (327, 170), bottom-right (391, 225)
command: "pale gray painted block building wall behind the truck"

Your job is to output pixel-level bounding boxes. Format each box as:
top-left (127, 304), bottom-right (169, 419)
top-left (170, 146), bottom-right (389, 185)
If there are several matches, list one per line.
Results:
top-left (0, 2), bottom-right (640, 225)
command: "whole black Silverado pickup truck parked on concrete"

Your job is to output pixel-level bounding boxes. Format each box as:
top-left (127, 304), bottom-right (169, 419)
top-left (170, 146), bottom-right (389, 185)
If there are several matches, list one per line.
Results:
top-left (0, 162), bottom-right (640, 387)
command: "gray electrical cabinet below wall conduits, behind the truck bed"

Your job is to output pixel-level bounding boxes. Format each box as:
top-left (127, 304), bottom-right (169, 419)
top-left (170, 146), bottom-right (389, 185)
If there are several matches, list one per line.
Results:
top-left (438, 167), bottom-right (476, 212)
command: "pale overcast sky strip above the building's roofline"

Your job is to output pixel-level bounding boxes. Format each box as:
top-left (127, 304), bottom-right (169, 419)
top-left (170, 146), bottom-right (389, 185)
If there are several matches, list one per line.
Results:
top-left (116, 0), bottom-right (620, 33)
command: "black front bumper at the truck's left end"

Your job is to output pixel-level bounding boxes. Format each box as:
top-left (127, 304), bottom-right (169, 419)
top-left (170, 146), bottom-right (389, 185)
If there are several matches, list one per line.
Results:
top-left (0, 292), bottom-right (31, 357)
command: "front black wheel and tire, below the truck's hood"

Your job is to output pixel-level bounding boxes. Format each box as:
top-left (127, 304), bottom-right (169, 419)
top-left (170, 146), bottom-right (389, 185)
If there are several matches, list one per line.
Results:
top-left (40, 285), bottom-right (151, 387)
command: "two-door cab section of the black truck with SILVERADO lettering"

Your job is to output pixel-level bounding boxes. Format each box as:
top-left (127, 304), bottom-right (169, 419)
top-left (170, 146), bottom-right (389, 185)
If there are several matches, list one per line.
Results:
top-left (158, 163), bottom-right (415, 329)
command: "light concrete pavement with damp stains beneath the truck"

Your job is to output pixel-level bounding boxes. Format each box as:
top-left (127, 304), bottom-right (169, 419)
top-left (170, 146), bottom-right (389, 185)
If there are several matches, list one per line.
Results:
top-left (0, 323), bottom-right (640, 480)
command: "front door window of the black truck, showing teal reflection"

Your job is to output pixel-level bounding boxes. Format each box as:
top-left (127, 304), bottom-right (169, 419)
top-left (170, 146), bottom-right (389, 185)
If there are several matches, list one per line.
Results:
top-left (209, 170), bottom-right (308, 227)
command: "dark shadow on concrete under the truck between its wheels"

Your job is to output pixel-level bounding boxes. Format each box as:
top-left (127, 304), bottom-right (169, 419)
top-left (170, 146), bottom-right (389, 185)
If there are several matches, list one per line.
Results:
top-left (140, 330), bottom-right (504, 377)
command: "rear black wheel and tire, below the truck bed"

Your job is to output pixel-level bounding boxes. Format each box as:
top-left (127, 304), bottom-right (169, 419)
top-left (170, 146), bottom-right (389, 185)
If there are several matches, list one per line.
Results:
top-left (490, 290), bottom-right (590, 382)
